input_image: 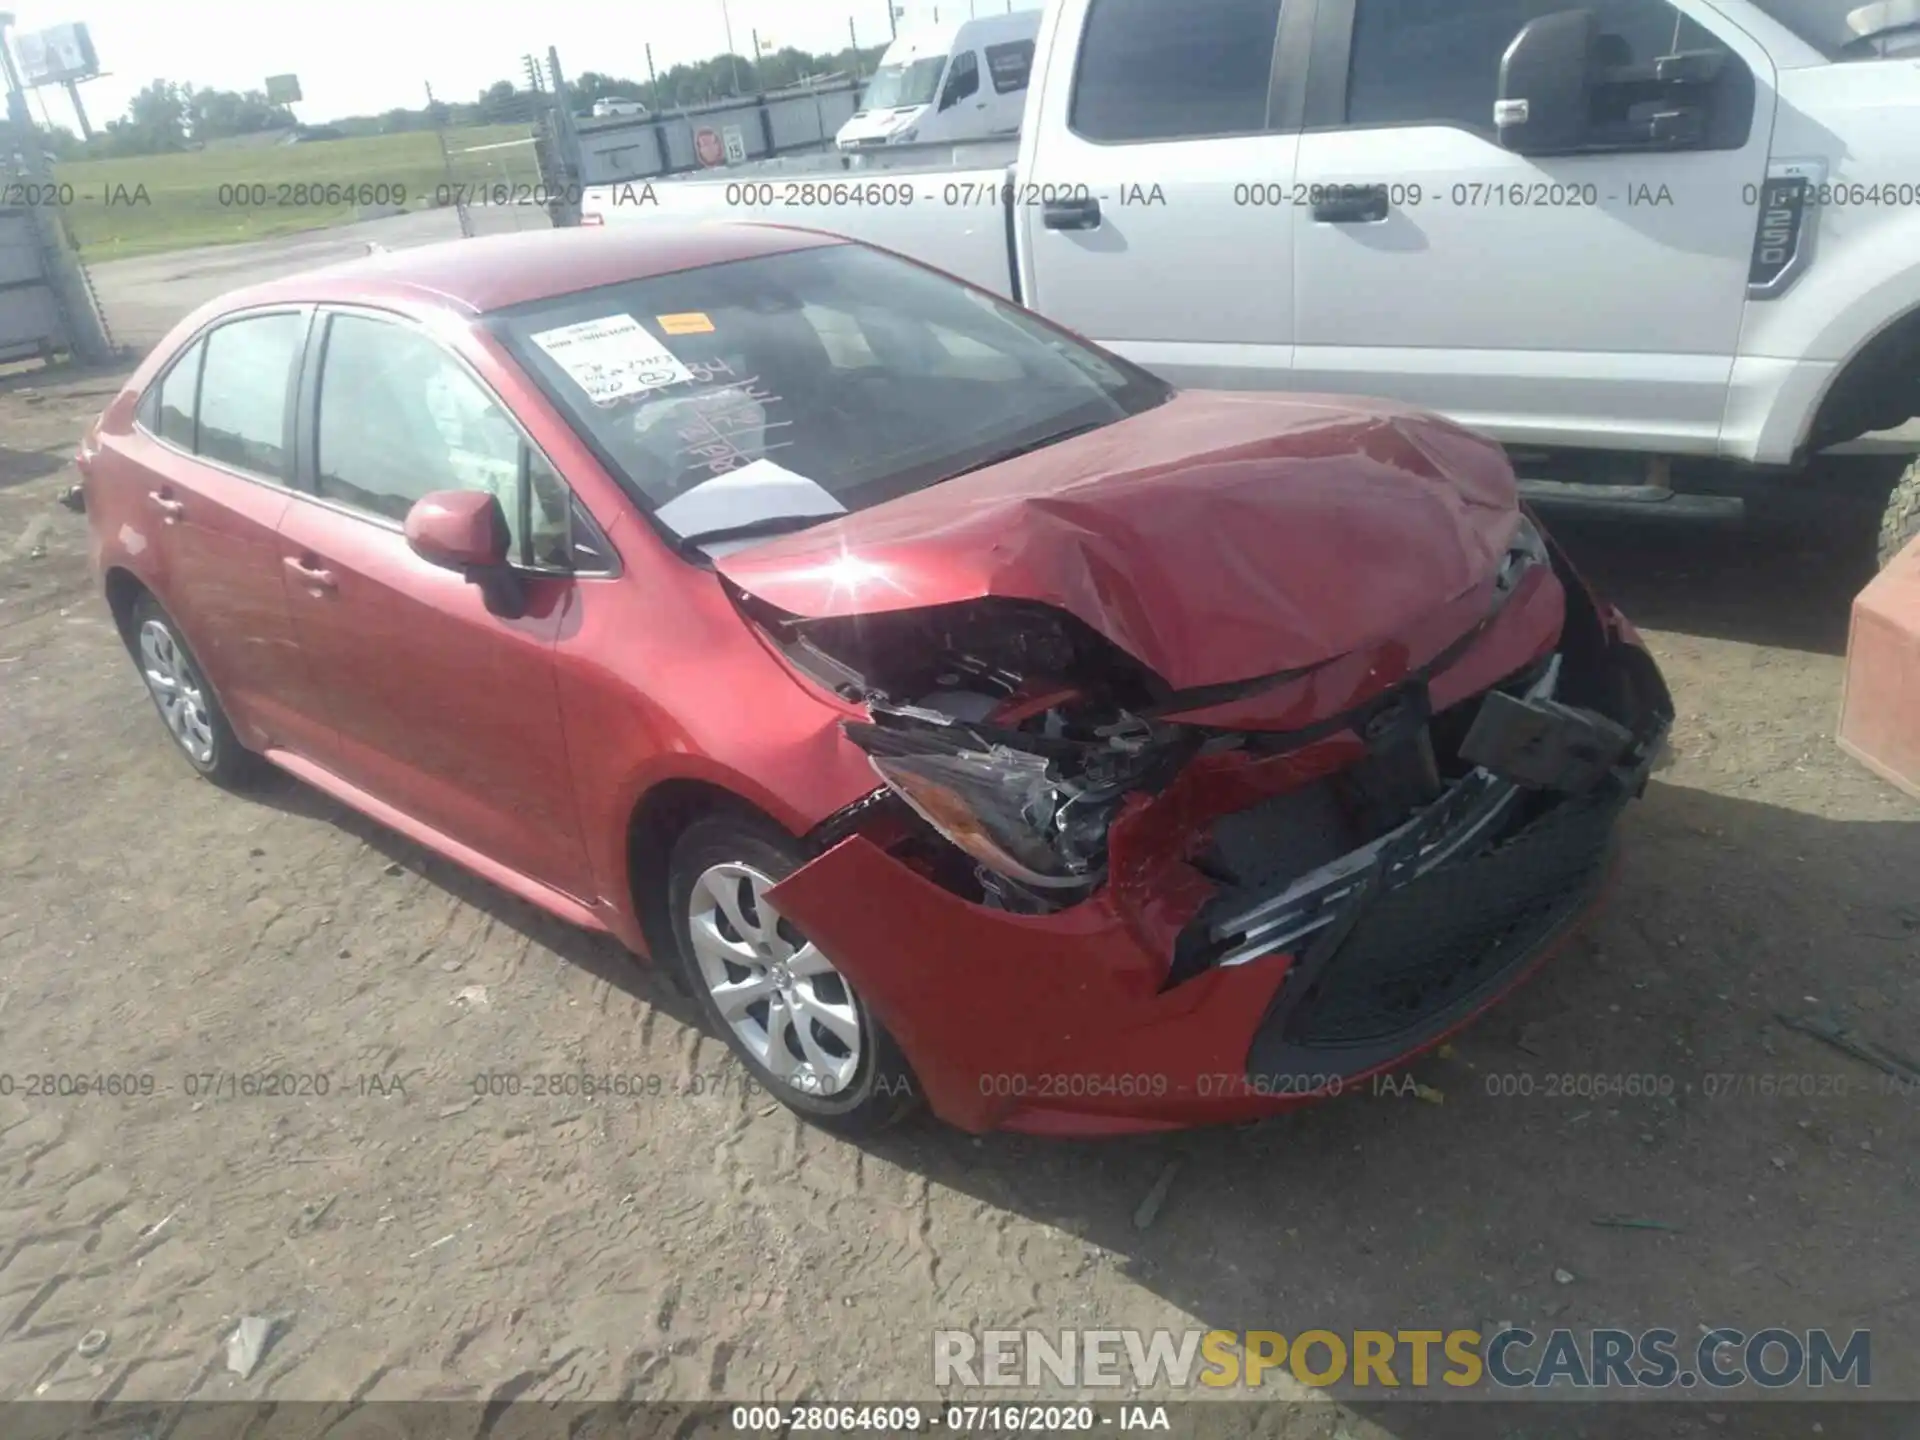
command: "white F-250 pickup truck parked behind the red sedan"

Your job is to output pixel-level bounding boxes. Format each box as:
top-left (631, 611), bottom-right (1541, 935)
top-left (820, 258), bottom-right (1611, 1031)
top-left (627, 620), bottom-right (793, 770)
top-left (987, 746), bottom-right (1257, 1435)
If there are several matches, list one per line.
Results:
top-left (582, 0), bottom-right (1920, 555)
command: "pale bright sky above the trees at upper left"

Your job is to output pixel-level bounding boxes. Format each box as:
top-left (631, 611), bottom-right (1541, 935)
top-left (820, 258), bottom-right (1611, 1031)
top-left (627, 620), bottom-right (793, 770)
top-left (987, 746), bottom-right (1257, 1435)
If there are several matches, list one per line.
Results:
top-left (13, 0), bottom-right (1035, 131)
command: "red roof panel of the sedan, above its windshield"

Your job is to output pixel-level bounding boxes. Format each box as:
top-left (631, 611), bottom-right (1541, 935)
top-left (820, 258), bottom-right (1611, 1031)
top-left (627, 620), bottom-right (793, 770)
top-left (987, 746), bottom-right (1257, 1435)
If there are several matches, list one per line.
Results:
top-left (221, 223), bottom-right (845, 313)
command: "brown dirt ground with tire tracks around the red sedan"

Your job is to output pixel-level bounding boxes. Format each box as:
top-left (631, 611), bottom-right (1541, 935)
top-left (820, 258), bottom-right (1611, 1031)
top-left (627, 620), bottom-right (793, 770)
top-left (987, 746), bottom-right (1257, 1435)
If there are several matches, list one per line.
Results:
top-left (0, 374), bottom-right (1920, 1440)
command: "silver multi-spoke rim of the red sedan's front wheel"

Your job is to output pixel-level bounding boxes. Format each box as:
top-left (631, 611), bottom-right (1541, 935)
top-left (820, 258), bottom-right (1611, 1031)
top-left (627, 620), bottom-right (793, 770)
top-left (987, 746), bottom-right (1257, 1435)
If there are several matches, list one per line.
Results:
top-left (687, 864), bottom-right (864, 1098)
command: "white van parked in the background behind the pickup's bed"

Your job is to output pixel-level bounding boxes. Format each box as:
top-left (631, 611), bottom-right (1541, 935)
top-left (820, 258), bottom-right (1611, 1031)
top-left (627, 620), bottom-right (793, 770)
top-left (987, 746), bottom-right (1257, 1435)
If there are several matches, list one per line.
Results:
top-left (835, 10), bottom-right (1041, 150)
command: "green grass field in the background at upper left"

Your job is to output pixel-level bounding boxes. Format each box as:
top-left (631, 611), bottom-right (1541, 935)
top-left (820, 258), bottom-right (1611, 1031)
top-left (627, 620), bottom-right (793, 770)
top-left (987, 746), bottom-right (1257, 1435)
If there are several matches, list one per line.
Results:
top-left (54, 125), bottom-right (540, 261)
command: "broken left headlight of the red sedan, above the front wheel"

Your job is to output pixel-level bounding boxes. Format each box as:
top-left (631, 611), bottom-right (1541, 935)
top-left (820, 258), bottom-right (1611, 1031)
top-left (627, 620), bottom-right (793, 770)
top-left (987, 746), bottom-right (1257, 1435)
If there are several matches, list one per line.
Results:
top-left (870, 747), bottom-right (1096, 889)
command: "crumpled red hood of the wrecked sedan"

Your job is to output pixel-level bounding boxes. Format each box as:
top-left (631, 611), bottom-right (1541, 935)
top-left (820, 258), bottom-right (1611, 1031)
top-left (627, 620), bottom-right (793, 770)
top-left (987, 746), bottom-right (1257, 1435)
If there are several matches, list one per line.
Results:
top-left (716, 392), bottom-right (1519, 689)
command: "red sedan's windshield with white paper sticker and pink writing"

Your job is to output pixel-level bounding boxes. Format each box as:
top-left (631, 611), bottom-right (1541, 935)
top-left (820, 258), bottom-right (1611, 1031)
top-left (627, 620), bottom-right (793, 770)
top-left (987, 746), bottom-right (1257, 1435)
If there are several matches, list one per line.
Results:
top-left (492, 244), bottom-right (1173, 540)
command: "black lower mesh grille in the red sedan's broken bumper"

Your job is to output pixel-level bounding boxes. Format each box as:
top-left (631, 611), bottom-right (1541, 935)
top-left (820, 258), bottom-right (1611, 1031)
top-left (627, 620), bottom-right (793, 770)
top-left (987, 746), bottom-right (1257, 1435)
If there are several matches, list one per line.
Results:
top-left (1248, 785), bottom-right (1628, 1077)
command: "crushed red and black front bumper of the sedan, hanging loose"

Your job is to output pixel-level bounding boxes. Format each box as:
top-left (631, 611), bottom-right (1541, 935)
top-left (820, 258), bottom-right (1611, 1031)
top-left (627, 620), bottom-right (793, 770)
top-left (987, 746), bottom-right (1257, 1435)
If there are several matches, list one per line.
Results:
top-left (770, 579), bottom-right (1672, 1135)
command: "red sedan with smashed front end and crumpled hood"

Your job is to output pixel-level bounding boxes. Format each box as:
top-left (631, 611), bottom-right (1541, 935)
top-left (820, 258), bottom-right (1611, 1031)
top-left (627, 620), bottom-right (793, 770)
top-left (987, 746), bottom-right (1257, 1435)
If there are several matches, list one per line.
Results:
top-left (79, 227), bottom-right (1670, 1135)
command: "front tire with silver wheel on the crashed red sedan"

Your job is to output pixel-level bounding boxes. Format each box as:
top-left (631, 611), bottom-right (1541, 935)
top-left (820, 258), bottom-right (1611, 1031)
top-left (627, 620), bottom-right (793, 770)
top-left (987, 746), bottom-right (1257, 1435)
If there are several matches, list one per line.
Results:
top-left (666, 814), bottom-right (920, 1137)
